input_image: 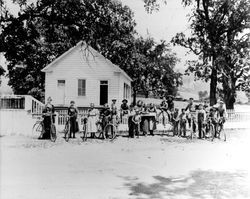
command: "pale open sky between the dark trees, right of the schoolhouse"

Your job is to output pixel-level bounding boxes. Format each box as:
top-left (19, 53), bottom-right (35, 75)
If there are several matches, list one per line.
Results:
top-left (121, 0), bottom-right (196, 72)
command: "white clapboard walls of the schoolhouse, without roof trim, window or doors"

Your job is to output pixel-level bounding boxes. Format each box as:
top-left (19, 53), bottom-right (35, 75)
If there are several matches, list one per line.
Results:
top-left (45, 43), bottom-right (130, 106)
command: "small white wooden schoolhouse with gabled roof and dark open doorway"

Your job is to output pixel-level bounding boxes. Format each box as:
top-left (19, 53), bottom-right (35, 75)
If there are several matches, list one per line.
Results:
top-left (42, 41), bottom-right (132, 107)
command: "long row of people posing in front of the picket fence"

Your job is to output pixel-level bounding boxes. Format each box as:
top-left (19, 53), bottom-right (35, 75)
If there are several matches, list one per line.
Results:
top-left (39, 96), bottom-right (226, 138)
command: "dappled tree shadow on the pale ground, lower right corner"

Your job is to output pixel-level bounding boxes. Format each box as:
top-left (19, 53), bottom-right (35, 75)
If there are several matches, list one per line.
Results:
top-left (124, 170), bottom-right (250, 199)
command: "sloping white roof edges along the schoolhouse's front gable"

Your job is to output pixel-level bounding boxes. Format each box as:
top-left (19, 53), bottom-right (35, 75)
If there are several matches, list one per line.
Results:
top-left (41, 41), bottom-right (133, 81)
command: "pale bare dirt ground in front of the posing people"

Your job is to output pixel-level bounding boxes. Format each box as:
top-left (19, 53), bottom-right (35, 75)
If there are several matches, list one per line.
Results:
top-left (0, 130), bottom-right (250, 199)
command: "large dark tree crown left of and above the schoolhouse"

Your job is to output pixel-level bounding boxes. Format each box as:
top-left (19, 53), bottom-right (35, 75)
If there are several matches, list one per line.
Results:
top-left (1, 0), bottom-right (135, 99)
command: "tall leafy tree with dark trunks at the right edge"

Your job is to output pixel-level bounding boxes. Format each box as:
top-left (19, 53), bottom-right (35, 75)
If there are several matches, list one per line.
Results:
top-left (145, 0), bottom-right (250, 109)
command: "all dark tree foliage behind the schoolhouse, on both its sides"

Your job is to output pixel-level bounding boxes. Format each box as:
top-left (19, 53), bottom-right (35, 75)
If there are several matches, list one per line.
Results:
top-left (0, 0), bottom-right (180, 102)
